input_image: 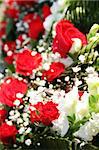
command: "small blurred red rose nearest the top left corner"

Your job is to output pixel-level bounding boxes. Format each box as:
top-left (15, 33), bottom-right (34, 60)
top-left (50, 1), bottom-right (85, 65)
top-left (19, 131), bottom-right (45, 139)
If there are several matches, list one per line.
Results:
top-left (5, 7), bottom-right (19, 19)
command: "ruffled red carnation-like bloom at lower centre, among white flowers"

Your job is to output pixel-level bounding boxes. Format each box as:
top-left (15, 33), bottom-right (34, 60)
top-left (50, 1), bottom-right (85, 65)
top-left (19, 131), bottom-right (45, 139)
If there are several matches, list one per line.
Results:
top-left (31, 101), bottom-right (59, 126)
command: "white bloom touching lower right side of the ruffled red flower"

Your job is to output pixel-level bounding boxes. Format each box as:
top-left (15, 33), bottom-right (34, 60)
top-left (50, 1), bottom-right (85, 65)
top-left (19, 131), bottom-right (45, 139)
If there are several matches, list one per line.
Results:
top-left (52, 114), bottom-right (69, 137)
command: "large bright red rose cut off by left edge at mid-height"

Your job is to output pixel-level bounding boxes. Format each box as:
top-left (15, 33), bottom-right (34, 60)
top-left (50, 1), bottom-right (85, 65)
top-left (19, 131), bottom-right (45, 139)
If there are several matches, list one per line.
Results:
top-left (0, 77), bottom-right (27, 107)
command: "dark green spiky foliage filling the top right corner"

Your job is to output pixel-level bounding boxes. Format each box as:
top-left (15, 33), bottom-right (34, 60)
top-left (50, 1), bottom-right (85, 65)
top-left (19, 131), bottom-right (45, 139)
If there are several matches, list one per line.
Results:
top-left (66, 0), bottom-right (99, 33)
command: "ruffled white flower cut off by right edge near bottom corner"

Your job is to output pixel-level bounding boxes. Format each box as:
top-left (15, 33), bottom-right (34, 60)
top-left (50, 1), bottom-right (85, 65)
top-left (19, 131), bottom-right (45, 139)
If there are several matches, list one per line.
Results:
top-left (74, 113), bottom-right (99, 141)
